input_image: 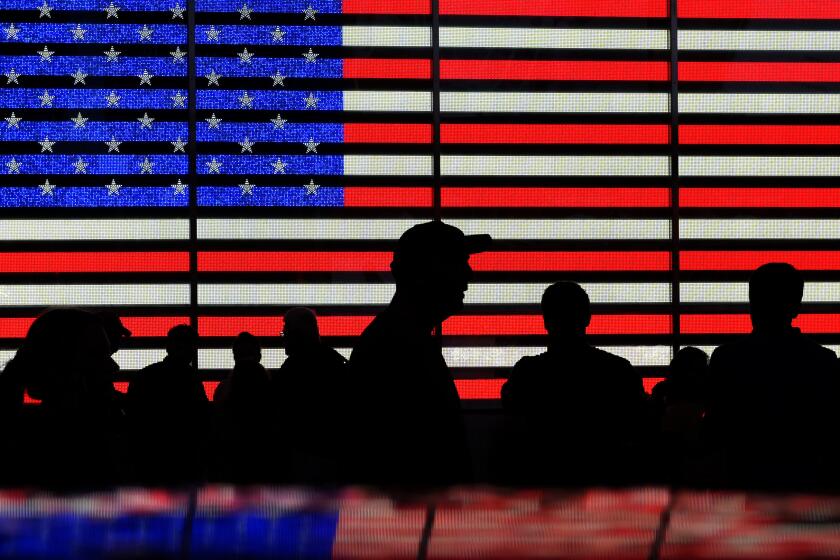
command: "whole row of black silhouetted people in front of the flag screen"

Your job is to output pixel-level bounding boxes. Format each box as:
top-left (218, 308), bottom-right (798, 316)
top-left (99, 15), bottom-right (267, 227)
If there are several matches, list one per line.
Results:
top-left (0, 222), bottom-right (840, 489)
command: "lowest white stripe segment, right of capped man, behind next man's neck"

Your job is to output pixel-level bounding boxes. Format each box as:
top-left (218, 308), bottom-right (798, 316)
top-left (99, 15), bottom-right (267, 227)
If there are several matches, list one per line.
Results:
top-left (443, 346), bottom-right (671, 368)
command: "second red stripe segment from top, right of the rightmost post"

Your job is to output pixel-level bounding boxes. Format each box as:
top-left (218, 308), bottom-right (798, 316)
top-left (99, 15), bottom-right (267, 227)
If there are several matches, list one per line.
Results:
top-left (679, 62), bottom-right (840, 82)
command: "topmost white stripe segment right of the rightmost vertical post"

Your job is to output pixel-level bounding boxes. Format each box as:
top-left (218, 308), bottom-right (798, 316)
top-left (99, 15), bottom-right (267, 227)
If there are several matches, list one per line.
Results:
top-left (678, 29), bottom-right (840, 51)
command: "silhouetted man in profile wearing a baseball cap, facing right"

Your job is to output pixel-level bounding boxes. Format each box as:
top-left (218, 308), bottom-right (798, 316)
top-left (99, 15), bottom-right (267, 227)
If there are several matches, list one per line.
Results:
top-left (346, 222), bottom-right (491, 486)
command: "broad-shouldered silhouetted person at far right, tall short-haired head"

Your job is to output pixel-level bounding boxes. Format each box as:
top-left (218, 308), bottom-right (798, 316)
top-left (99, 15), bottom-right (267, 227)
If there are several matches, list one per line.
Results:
top-left (705, 263), bottom-right (840, 488)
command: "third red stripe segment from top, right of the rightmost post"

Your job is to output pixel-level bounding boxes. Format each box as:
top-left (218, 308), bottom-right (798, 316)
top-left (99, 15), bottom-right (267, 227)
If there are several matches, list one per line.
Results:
top-left (680, 124), bottom-right (840, 144)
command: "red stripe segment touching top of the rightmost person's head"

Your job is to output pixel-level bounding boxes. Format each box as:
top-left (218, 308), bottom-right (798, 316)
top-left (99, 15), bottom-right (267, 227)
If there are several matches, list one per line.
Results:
top-left (680, 251), bottom-right (840, 270)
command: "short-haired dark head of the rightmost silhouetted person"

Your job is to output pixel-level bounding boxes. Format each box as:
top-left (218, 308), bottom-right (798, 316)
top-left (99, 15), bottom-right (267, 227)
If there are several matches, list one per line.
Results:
top-left (750, 263), bottom-right (805, 330)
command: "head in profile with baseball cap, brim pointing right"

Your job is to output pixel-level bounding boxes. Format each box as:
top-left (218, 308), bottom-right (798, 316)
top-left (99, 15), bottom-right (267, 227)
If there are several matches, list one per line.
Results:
top-left (391, 221), bottom-right (491, 325)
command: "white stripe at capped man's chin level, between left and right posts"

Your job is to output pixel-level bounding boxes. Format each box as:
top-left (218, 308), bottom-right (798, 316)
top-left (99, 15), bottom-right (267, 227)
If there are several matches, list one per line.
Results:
top-left (198, 282), bottom-right (671, 306)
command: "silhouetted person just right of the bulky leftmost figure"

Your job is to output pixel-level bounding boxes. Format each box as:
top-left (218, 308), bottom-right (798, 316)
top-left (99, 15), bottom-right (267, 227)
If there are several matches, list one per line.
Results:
top-left (127, 325), bottom-right (210, 484)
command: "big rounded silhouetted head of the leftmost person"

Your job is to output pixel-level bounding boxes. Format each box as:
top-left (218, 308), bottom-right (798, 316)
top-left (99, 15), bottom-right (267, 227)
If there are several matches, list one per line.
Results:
top-left (7, 308), bottom-right (111, 402)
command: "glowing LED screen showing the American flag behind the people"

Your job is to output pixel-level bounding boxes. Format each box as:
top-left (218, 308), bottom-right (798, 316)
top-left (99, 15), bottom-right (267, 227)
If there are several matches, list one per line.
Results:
top-left (0, 0), bottom-right (840, 399)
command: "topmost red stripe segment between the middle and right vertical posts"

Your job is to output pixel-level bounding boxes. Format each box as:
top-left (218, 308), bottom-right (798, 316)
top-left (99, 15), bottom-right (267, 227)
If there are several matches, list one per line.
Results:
top-left (440, 0), bottom-right (668, 18)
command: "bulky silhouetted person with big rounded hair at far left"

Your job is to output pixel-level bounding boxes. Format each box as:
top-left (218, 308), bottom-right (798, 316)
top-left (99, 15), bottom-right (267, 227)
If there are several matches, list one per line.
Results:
top-left (0, 308), bottom-right (123, 488)
